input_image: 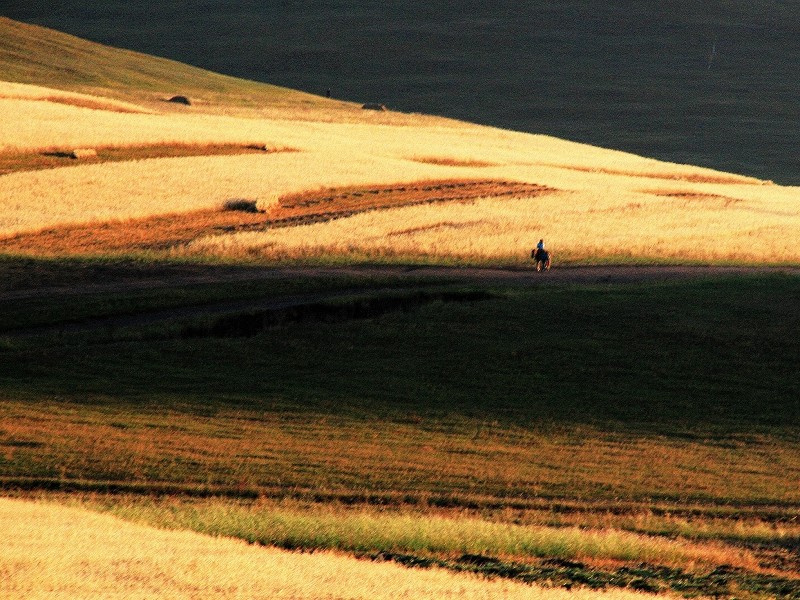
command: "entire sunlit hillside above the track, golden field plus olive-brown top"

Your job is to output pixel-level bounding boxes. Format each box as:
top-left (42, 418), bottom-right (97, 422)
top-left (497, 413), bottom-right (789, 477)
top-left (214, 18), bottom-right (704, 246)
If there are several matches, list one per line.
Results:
top-left (0, 20), bottom-right (800, 264)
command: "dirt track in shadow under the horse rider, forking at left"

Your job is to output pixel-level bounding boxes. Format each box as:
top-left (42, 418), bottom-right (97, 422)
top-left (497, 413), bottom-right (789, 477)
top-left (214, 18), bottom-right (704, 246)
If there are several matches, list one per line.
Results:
top-left (0, 265), bottom-right (800, 337)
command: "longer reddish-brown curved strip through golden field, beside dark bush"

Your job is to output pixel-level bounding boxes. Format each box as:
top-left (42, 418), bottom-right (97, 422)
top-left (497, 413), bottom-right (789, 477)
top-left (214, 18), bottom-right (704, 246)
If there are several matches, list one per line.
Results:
top-left (0, 178), bottom-right (555, 255)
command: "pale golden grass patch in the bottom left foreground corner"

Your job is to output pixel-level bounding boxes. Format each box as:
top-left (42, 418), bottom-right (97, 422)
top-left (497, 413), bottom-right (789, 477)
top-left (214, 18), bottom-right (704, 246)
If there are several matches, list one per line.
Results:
top-left (0, 499), bottom-right (664, 600)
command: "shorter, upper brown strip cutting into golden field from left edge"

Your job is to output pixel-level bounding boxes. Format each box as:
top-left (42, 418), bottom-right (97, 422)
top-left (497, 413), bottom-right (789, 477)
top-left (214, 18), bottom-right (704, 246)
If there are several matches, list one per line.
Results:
top-left (0, 144), bottom-right (297, 175)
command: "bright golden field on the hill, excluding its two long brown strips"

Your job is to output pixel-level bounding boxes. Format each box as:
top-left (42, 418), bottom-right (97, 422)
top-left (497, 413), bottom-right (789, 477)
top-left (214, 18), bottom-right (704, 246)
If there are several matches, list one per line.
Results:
top-left (0, 83), bottom-right (800, 263)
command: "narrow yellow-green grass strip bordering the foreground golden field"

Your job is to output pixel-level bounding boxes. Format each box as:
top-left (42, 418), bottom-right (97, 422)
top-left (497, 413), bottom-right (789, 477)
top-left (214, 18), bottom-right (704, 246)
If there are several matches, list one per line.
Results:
top-left (89, 500), bottom-right (759, 570)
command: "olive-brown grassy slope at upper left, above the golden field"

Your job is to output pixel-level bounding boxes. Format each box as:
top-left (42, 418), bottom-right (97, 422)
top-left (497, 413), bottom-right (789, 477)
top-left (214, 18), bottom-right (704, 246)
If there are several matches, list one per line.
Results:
top-left (0, 17), bottom-right (330, 105)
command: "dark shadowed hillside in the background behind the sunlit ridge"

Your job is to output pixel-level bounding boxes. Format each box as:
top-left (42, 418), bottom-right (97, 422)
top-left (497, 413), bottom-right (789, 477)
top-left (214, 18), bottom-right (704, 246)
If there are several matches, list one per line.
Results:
top-left (0, 0), bottom-right (800, 184)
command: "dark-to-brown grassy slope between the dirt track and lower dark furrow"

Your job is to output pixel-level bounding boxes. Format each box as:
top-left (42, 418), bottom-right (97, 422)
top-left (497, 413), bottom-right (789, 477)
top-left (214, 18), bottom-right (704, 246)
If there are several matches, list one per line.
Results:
top-left (0, 270), bottom-right (800, 505)
